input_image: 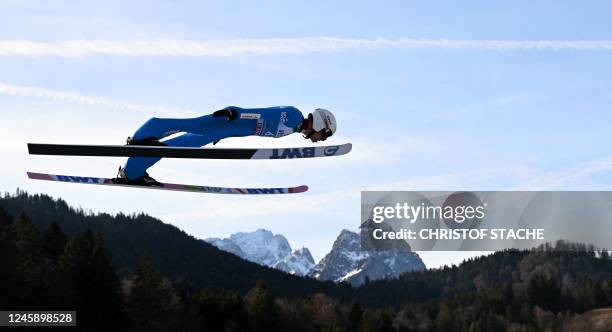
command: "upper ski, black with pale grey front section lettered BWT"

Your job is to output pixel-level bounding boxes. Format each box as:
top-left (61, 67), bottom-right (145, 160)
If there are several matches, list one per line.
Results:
top-left (28, 143), bottom-right (352, 159)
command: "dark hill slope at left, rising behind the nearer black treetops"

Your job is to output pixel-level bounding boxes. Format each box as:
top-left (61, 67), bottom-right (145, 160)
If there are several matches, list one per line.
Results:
top-left (0, 192), bottom-right (352, 297)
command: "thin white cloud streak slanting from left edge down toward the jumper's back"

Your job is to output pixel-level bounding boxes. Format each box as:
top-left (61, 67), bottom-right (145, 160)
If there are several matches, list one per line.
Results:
top-left (0, 82), bottom-right (197, 116)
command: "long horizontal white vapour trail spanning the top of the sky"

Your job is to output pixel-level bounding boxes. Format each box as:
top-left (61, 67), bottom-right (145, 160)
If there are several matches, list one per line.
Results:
top-left (0, 37), bottom-right (612, 57)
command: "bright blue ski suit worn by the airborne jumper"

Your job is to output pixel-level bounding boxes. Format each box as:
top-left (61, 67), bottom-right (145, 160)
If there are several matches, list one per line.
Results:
top-left (124, 106), bottom-right (304, 180)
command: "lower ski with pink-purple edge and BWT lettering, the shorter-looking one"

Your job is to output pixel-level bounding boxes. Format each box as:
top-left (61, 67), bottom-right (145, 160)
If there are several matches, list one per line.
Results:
top-left (27, 172), bottom-right (308, 195)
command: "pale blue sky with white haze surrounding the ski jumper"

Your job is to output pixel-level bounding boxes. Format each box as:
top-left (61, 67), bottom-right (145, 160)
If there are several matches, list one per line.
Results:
top-left (0, 1), bottom-right (612, 266)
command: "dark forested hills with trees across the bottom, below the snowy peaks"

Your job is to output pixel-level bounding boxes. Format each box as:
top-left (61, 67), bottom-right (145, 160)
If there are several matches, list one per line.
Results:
top-left (0, 192), bottom-right (612, 331)
